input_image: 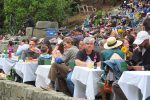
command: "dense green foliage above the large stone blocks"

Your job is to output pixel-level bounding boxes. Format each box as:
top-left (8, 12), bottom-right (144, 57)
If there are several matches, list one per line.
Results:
top-left (4, 0), bottom-right (73, 34)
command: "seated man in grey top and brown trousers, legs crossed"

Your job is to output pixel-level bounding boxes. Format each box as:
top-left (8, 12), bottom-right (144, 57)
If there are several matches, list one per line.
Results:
top-left (48, 37), bottom-right (79, 95)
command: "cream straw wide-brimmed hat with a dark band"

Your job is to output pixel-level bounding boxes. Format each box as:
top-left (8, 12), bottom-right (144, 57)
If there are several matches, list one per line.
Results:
top-left (104, 37), bottom-right (122, 49)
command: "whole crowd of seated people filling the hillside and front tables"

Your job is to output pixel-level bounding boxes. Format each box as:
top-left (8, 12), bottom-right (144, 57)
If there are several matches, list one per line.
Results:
top-left (0, 0), bottom-right (150, 100)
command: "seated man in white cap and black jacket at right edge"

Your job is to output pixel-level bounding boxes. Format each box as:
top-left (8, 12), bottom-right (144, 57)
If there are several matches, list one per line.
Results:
top-left (112, 31), bottom-right (150, 100)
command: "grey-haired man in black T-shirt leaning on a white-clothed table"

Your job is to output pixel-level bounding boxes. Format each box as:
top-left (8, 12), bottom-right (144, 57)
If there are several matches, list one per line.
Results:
top-left (75, 37), bottom-right (100, 67)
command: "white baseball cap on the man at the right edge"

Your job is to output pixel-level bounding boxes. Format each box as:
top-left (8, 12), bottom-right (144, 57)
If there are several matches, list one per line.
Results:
top-left (133, 31), bottom-right (150, 45)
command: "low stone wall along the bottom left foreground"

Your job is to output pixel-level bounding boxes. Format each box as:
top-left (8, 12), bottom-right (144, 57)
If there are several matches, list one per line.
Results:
top-left (0, 80), bottom-right (85, 100)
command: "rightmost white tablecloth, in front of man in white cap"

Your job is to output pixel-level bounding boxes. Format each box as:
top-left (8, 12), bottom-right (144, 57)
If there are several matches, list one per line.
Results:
top-left (118, 71), bottom-right (150, 100)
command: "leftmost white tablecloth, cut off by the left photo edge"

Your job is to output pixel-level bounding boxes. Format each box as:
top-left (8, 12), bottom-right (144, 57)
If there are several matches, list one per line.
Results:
top-left (0, 58), bottom-right (18, 74)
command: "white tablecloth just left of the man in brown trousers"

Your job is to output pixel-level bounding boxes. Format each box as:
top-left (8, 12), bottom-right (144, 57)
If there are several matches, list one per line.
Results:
top-left (35, 65), bottom-right (51, 87)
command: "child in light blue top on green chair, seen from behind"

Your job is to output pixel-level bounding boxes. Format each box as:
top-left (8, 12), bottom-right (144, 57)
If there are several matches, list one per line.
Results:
top-left (38, 45), bottom-right (51, 65)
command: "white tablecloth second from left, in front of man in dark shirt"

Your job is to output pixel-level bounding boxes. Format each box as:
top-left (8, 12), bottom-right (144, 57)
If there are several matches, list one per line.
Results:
top-left (14, 62), bottom-right (38, 82)
